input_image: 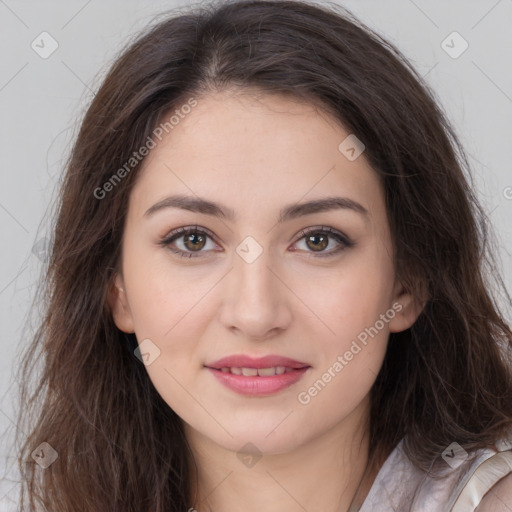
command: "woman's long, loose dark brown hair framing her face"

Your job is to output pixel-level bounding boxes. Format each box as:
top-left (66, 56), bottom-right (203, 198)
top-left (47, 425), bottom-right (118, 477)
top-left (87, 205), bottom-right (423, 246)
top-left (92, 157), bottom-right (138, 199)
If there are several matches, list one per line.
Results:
top-left (14, 0), bottom-right (512, 512)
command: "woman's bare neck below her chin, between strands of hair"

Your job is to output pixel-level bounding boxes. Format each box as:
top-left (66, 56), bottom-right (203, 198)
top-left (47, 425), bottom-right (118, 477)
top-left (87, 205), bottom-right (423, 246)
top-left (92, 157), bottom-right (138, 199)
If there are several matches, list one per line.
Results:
top-left (185, 401), bottom-right (378, 512)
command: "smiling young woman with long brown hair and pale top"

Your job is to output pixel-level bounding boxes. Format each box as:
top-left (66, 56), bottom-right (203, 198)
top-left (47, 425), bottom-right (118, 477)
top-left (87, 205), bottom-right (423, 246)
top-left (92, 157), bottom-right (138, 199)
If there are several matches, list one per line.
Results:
top-left (14, 1), bottom-right (512, 512)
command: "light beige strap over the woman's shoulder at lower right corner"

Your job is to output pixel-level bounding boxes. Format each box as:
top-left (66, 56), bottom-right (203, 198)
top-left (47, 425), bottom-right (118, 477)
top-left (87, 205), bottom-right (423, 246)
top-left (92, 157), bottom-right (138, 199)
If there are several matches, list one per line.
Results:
top-left (451, 450), bottom-right (512, 512)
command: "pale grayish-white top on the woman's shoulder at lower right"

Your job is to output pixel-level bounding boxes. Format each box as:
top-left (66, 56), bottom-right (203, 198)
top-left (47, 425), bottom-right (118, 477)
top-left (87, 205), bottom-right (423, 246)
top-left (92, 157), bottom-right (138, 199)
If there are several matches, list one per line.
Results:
top-left (359, 436), bottom-right (512, 512)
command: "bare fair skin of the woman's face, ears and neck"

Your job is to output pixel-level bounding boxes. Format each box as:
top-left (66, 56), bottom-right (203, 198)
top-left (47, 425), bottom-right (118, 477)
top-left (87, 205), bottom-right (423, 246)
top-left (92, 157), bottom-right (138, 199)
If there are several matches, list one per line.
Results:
top-left (110, 90), bottom-right (421, 512)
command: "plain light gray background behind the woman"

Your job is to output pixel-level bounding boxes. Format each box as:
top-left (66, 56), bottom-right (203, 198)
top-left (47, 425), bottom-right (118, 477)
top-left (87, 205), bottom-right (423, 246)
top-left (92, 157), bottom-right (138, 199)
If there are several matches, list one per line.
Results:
top-left (0, 0), bottom-right (512, 504)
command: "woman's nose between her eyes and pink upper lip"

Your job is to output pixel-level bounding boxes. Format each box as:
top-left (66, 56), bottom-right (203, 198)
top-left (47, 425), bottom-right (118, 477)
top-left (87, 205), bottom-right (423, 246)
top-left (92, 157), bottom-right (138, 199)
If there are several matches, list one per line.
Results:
top-left (220, 246), bottom-right (293, 341)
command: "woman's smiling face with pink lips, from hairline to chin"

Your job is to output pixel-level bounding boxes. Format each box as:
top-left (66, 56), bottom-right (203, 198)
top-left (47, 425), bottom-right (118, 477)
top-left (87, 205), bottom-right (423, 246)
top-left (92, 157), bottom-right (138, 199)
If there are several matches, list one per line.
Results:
top-left (110, 92), bottom-right (418, 453)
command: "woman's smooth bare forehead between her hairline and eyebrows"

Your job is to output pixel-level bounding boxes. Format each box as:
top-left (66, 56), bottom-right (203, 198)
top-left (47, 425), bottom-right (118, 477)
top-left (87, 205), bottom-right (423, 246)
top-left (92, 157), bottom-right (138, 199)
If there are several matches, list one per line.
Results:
top-left (128, 91), bottom-right (382, 222)
